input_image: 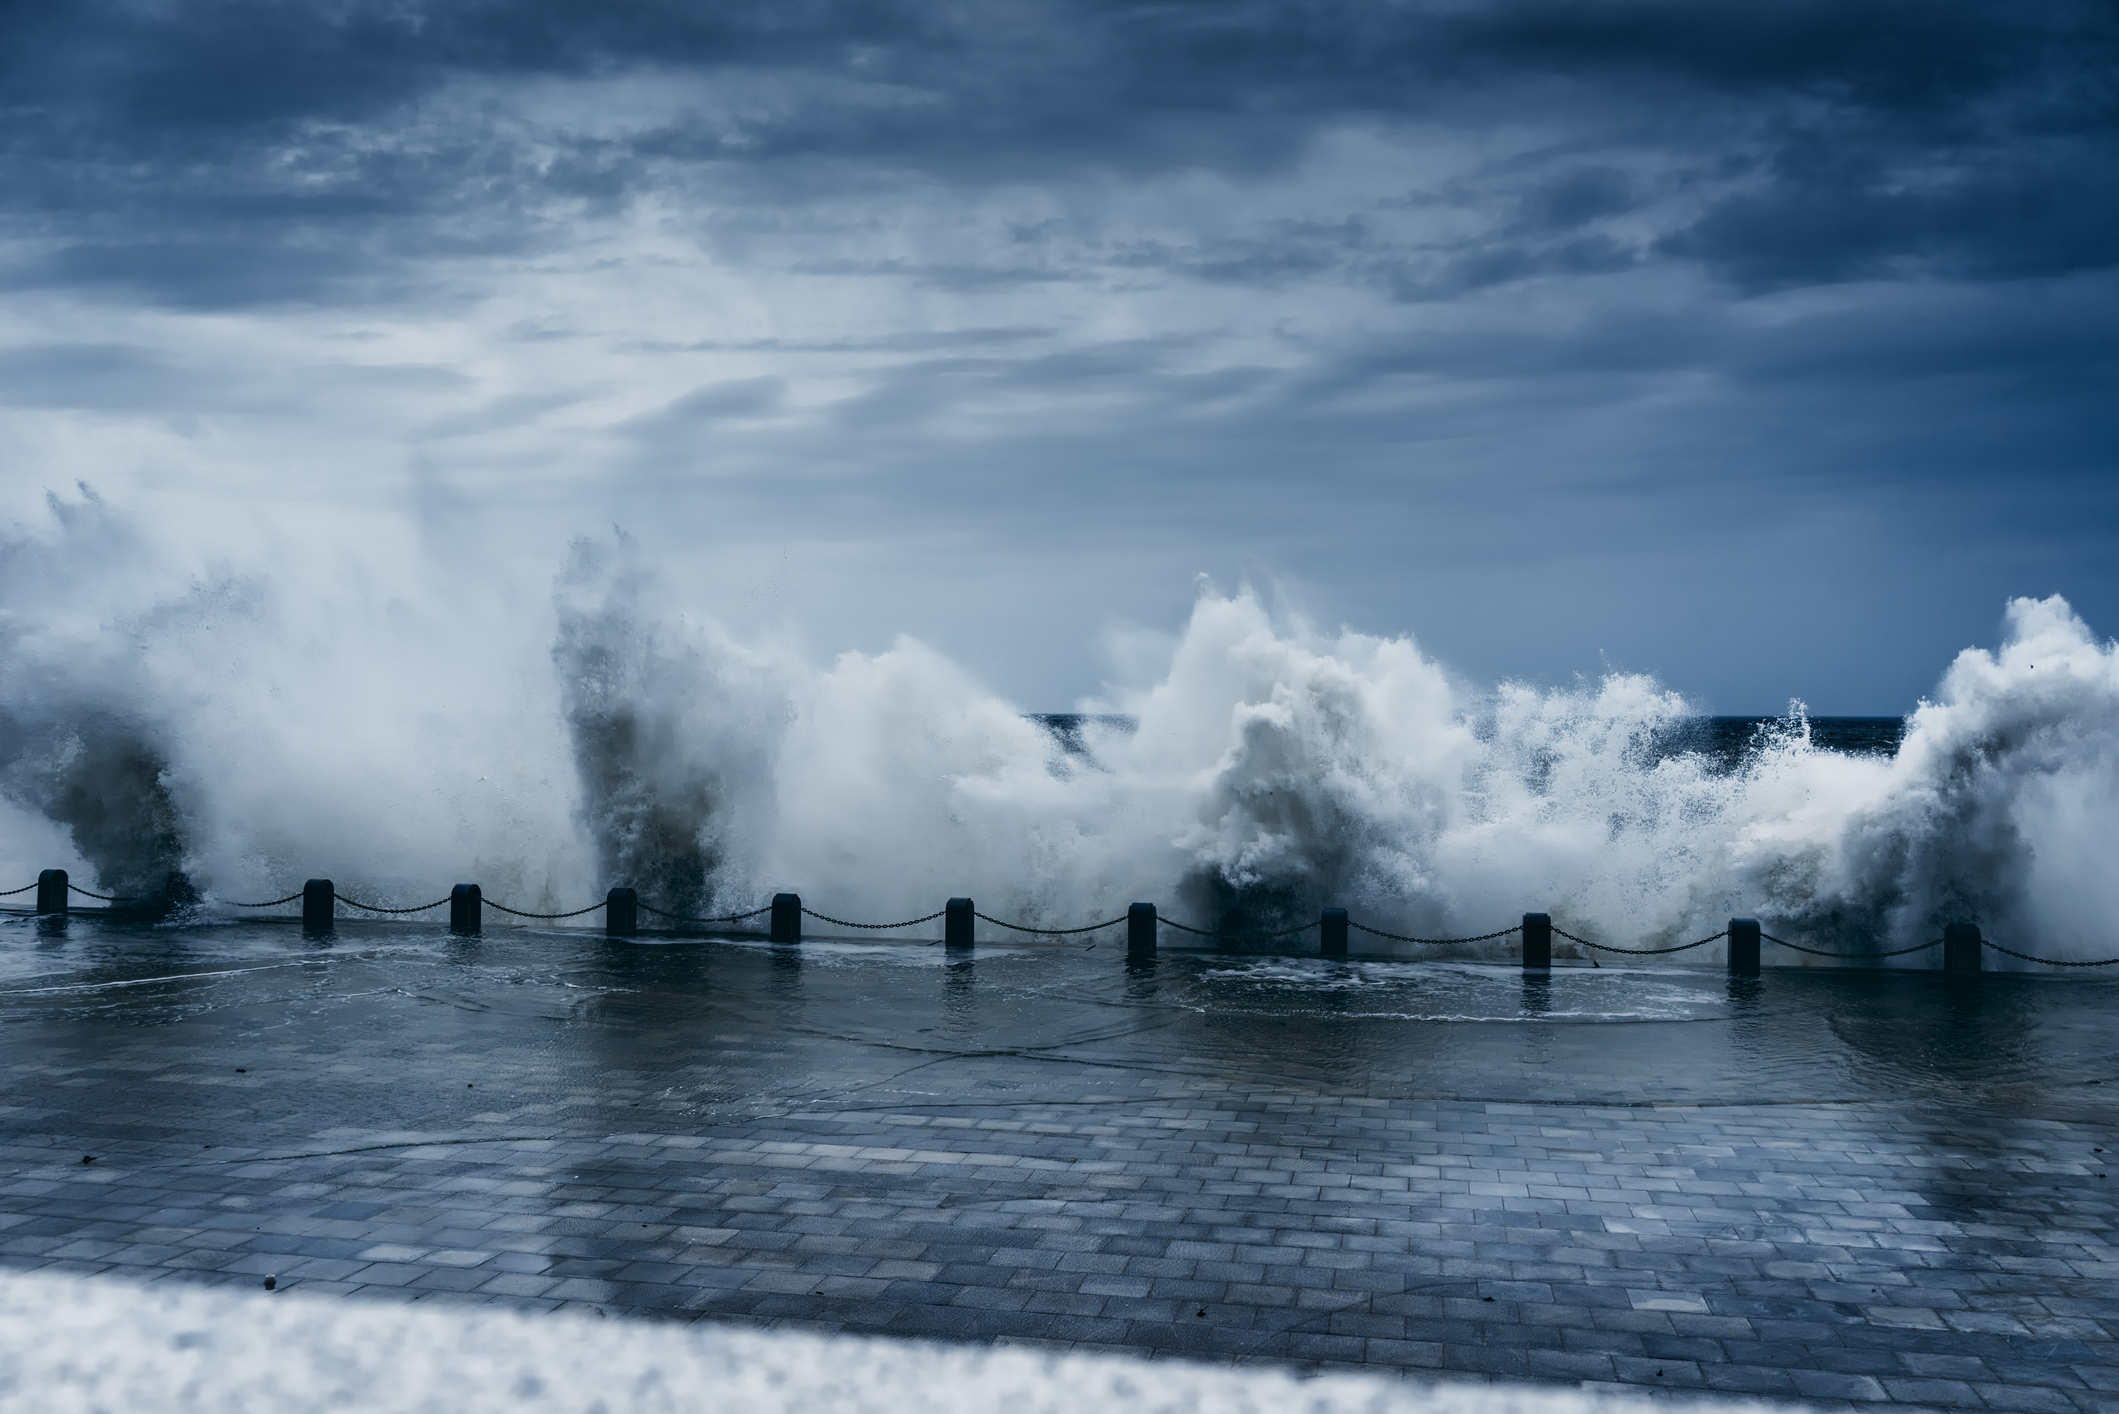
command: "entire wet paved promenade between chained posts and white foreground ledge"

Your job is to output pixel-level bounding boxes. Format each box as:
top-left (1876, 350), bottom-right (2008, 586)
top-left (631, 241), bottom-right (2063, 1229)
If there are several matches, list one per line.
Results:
top-left (0, 920), bottom-right (2119, 1414)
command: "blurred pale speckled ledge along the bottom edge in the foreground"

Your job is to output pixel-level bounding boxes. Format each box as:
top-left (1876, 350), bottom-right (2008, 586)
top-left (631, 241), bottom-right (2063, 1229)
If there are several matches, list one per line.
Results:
top-left (0, 1274), bottom-right (1737, 1414)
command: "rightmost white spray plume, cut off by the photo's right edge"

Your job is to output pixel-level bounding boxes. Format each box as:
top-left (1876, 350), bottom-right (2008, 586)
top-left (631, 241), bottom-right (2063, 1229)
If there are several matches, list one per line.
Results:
top-left (1735, 596), bottom-right (2119, 967)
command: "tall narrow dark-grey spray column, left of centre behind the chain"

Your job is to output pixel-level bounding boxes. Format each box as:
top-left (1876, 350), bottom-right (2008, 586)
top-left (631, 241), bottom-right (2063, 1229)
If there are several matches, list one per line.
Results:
top-left (551, 532), bottom-right (786, 916)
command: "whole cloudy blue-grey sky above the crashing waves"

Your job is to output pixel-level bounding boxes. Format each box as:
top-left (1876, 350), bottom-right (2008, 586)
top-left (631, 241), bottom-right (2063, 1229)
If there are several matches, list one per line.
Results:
top-left (0, 0), bottom-right (2119, 712)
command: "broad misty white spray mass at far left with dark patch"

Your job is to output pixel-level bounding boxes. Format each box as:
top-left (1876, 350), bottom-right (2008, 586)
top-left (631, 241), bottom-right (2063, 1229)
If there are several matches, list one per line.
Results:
top-left (0, 490), bottom-right (591, 905)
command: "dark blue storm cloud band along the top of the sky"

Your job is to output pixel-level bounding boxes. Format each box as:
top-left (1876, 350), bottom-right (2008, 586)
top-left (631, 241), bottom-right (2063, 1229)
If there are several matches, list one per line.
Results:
top-left (0, 0), bottom-right (2119, 305)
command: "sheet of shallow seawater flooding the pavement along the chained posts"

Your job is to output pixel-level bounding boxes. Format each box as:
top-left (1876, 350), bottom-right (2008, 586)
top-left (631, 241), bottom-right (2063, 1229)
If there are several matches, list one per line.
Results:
top-left (0, 920), bottom-right (2119, 1136)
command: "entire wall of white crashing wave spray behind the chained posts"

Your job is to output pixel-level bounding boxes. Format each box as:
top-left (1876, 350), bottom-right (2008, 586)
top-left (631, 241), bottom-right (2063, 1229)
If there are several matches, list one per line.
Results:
top-left (0, 491), bottom-right (2119, 965)
